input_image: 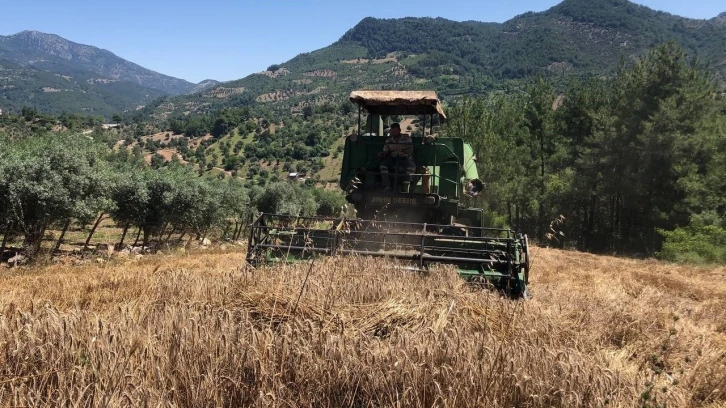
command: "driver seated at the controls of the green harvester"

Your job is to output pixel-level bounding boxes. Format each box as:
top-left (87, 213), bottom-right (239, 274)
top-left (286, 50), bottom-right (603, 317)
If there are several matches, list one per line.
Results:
top-left (378, 123), bottom-right (416, 193)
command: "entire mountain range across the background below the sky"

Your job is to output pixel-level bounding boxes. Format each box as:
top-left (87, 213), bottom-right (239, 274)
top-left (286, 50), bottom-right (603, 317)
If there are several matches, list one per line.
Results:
top-left (0, 0), bottom-right (726, 119)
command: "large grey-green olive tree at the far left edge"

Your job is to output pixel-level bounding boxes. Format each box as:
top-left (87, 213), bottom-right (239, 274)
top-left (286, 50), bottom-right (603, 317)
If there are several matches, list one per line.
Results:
top-left (0, 134), bottom-right (111, 253)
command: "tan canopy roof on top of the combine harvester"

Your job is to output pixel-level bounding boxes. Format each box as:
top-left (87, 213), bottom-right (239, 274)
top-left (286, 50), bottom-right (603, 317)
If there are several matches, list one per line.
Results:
top-left (350, 91), bottom-right (446, 120)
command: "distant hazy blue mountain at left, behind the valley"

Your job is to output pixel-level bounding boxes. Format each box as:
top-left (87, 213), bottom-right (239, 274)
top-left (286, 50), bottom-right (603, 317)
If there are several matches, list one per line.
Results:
top-left (0, 31), bottom-right (217, 116)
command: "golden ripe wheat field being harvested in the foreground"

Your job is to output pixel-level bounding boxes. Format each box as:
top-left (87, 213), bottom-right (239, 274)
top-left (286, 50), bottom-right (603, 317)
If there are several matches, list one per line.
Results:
top-left (0, 248), bottom-right (726, 408)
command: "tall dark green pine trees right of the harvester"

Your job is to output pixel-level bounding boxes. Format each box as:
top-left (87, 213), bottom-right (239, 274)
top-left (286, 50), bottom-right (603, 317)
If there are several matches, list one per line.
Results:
top-left (445, 42), bottom-right (726, 262)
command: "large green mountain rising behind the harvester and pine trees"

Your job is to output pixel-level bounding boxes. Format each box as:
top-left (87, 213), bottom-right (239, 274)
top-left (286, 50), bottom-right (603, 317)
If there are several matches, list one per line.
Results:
top-left (150, 0), bottom-right (726, 118)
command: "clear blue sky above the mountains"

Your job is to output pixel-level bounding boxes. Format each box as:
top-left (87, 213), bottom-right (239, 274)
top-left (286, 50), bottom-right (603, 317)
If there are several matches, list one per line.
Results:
top-left (0, 0), bottom-right (726, 82)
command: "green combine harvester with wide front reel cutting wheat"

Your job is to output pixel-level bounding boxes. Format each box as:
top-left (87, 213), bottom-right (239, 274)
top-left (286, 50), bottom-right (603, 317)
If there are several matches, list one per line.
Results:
top-left (247, 91), bottom-right (529, 297)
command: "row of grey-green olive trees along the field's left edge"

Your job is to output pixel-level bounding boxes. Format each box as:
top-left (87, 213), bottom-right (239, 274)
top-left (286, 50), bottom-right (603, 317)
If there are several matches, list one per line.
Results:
top-left (0, 134), bottom-right (344, 255)
